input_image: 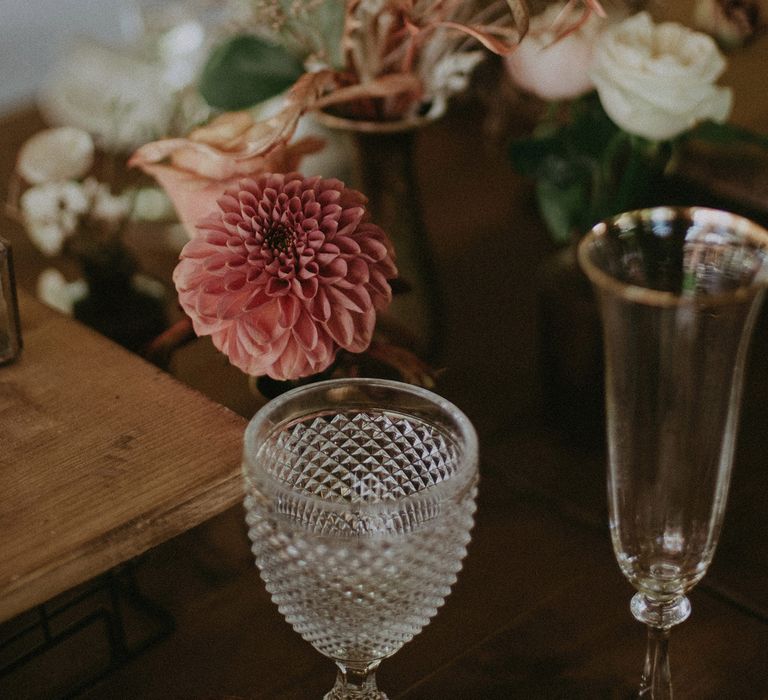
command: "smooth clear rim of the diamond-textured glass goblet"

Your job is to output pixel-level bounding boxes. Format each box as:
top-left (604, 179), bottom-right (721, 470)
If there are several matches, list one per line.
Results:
top-left (242, 378), bottom-right (478, 514)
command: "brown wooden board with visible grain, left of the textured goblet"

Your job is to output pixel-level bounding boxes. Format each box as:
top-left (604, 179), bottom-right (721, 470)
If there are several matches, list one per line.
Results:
top-left (0, 291), bottom-right (244, 621)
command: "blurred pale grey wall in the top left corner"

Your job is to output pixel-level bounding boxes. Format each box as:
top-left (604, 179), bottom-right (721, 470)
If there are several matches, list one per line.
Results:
top-left (0, 0), bottom-right (133, 113)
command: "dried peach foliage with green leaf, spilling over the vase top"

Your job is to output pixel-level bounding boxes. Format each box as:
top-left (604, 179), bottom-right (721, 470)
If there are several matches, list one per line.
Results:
top-left (201, 0), bottom-right (528, 121)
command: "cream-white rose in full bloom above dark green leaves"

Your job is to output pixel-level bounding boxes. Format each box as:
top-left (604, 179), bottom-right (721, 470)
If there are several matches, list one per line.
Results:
top-left (589, 12), bottom-right (732, 141)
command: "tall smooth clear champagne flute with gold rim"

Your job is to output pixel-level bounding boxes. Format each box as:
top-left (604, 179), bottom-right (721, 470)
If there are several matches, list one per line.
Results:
top-left (579, 207), bottom-right (768, 700)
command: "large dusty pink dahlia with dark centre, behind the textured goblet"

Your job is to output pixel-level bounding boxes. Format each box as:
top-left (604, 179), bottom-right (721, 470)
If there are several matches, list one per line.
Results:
top-left (173, 173), bottom-right (397, 379)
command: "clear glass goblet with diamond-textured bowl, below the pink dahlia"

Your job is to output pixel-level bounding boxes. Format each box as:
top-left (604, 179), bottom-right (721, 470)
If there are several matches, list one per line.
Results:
top-left (243, 379), bottom-right (477, 700)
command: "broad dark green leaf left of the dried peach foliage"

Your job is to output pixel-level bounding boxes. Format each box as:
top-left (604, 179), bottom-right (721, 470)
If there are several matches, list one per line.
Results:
top-left (199, 34), bottom-right (304, 111)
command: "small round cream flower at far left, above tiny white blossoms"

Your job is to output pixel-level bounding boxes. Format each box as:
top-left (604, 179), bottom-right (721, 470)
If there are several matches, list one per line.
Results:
top-left (16, 126), bottom-right (94, 185)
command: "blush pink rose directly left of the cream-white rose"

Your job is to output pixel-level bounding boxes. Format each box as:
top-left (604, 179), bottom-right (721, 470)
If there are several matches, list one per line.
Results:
top-left (506, 4), bottom-right (606, 101)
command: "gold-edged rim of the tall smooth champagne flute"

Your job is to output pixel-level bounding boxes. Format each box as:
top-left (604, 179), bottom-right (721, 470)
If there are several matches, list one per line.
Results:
top-left (577, 206), bottom-right (768, 307)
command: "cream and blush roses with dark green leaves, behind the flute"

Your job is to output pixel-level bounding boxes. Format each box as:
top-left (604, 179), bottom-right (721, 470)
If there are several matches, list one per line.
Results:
top-left (507, 6), bottom-right (768, 243)
